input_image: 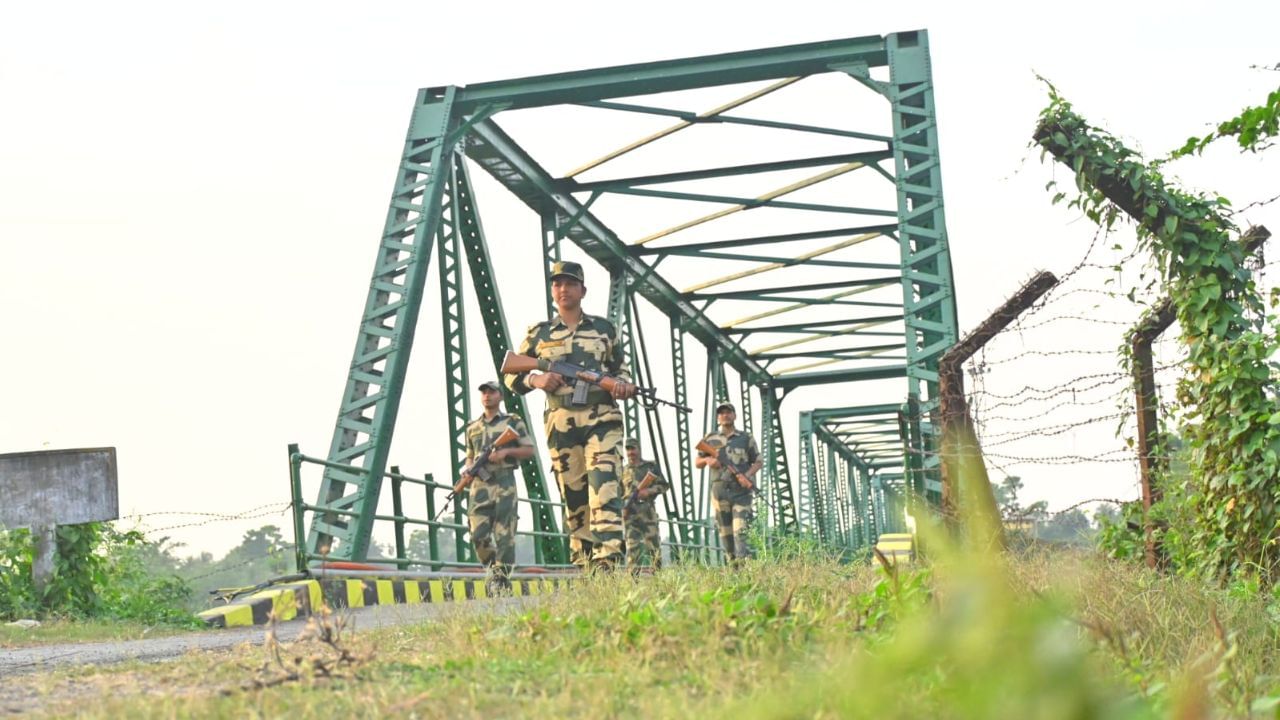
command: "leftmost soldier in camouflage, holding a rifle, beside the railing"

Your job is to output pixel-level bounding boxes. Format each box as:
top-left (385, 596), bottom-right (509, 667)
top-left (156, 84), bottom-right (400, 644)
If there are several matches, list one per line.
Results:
top-left (461, 380), bottom-right (534, 591)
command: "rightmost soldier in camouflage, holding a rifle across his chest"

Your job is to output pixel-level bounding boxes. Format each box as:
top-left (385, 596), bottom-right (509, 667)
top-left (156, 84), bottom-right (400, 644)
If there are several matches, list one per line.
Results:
top-left (694, 401), bottom-right (764, 565)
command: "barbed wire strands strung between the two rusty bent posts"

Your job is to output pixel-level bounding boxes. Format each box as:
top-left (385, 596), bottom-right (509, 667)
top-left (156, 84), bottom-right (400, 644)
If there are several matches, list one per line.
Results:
top-left (964, 229), bottom-right (1184, 527)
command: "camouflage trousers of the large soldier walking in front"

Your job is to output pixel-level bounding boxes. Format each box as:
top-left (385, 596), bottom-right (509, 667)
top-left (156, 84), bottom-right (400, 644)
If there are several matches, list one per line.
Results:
top-left (547, 405), bottom-right (622, 568)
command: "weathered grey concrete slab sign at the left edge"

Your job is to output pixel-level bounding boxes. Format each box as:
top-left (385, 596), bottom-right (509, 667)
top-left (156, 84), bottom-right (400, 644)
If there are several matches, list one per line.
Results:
top-left (0, 447), bottom-right (120, 528)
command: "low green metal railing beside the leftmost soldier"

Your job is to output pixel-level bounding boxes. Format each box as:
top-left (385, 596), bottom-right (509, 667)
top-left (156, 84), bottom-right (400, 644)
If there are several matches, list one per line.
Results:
top-left (289, 445), bottom-right (573, 573)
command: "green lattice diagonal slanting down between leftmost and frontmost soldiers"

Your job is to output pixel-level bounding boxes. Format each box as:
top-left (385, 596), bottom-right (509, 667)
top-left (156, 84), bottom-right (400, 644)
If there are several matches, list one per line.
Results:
top-left (453, 154), bottom-right (568, 562)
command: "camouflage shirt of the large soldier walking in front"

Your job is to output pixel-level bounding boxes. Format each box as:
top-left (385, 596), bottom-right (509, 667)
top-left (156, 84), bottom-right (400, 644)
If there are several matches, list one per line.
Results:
top-left (503, 313), bottom-right (631, 407)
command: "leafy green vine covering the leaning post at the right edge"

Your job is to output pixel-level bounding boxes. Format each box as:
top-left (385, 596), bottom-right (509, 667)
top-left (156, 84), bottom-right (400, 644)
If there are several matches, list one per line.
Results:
top-left (1034, 86), bottom-right (1280, 580)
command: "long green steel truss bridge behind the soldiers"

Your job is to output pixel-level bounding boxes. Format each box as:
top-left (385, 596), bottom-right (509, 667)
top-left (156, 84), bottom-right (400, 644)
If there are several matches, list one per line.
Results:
top-left (293, 31), bottom-right (957, 568)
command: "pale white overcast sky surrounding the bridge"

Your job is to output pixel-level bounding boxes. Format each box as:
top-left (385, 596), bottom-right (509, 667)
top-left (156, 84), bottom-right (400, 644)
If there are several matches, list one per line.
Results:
top-left (0, 0), bottom-right (1280, 553)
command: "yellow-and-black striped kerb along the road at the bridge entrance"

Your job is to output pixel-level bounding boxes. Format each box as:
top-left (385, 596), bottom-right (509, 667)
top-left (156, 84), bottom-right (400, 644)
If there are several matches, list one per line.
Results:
top-left (198, 577), bottom-right (568, 628)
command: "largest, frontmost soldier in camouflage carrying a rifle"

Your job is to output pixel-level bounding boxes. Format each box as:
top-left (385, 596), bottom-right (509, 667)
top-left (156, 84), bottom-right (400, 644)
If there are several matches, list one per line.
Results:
top-left (506, 263), bottom-right (635, 570)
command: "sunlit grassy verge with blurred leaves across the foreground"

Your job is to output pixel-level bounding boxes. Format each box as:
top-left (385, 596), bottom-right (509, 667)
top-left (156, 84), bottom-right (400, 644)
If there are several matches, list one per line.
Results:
top-left (17, 540), bottom-right (1280, 719)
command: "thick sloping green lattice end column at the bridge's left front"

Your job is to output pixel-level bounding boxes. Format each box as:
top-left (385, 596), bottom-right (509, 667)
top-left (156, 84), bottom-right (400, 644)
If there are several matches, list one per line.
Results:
top-left (307, 86), bottom-right (456, 560)
